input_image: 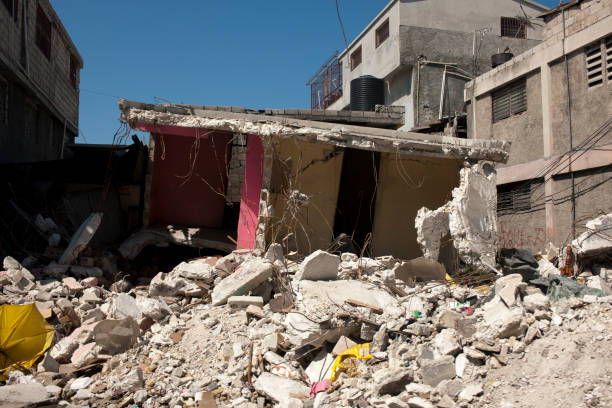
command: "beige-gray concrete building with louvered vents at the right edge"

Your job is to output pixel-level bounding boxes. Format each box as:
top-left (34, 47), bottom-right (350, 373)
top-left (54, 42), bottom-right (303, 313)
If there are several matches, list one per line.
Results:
top-left (464, 0), bottom-right (612, 250)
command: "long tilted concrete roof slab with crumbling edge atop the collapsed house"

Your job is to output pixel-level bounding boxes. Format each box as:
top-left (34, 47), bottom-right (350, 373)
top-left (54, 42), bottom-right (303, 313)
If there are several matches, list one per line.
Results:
top-left (119, 99), bottom-right (510, 163)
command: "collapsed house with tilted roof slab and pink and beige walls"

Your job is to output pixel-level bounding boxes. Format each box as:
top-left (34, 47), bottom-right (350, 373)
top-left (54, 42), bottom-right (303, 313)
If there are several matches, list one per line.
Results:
top-left (119, 100), bottom-right (509, 267)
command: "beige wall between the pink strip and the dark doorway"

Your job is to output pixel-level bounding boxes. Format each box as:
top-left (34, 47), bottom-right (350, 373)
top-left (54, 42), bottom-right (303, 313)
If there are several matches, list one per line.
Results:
top-left (269, 139), bottom-right (343, 254)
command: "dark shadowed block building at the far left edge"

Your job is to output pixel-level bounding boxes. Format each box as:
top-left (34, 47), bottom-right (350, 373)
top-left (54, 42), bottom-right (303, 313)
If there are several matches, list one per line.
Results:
top-left (0, 0), bottom-right (83, 163)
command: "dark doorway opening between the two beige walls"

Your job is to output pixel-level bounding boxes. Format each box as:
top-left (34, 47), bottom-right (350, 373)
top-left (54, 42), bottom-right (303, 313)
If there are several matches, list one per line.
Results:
top-left (334, 149), bottom-right (380, 252)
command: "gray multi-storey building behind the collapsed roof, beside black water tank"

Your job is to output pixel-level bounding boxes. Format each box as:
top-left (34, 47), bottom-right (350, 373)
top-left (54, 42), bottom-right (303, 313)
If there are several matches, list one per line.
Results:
top-left (311, 0), bottom-right (547, 130)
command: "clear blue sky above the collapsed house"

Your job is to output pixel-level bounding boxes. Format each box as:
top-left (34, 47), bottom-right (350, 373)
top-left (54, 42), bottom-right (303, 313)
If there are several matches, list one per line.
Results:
top-left (51, 0), bottom-right (559, 143)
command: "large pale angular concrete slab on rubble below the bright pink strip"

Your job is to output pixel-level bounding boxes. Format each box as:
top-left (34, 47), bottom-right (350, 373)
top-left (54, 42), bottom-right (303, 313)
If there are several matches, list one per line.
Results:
top-left (212, 259), bottom-right (274, 306)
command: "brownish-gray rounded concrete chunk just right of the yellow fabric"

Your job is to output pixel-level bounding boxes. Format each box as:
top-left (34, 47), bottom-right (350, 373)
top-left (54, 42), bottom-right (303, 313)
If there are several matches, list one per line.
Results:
top-left (94, 317), bottom-right (140, 354)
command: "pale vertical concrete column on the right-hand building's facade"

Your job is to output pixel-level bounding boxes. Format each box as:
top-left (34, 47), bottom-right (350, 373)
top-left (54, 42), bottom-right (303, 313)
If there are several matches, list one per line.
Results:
top-left (540, 62), bottom-right (555, 242)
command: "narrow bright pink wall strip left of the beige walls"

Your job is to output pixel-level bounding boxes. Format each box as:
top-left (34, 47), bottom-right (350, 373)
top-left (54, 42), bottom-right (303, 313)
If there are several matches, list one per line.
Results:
top-left (238, 135), bottom-right (264, 249)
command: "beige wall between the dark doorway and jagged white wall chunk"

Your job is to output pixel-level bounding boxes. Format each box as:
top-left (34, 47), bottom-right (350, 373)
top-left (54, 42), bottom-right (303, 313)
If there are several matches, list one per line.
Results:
top-left (372, 153), bottom-right (461, 259)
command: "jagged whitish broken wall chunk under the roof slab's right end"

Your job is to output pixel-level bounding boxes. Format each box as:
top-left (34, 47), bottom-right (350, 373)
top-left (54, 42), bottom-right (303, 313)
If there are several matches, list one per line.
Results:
top-left (415, 162), bottom-right (497, 272)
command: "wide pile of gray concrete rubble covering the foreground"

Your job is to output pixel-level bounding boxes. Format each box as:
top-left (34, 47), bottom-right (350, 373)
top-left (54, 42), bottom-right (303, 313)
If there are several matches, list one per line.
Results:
top-left (0, 237), bottom-right (612, 408)
